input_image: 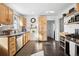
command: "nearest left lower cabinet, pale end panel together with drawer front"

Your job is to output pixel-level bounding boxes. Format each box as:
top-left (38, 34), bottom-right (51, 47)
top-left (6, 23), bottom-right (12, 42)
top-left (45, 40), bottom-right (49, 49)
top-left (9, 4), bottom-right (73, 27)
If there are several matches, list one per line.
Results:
top-left (0, 36), bottom-right (16, 56)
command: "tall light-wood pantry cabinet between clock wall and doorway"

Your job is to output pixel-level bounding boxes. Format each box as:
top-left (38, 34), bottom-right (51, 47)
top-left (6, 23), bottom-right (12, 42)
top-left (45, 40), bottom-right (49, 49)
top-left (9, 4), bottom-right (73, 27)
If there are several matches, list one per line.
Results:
top-left (38, 16), bottom-right (47, 41)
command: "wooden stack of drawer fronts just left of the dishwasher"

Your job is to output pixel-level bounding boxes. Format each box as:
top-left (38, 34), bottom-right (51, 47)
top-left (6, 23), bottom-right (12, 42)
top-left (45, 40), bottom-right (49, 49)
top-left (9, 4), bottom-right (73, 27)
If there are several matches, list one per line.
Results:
top-left (8, 37), bottom-right (16, 56)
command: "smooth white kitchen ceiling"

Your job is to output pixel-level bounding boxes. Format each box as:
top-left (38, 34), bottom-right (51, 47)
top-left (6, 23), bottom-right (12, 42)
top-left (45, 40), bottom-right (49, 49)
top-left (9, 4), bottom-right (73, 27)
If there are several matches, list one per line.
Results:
top-left (7, 3), bottom-right (73, 16)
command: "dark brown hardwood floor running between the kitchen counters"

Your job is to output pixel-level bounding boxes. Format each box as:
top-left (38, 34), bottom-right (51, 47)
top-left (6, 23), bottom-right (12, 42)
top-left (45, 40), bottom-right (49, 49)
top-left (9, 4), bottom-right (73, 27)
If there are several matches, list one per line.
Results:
top-left (16, 38), bottom-right (64, 56)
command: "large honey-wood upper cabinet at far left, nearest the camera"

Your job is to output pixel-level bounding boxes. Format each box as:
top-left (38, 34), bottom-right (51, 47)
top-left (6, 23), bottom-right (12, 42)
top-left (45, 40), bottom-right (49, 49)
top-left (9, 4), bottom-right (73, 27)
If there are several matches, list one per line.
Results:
top-left (0, 4), bottom-right (13, 25)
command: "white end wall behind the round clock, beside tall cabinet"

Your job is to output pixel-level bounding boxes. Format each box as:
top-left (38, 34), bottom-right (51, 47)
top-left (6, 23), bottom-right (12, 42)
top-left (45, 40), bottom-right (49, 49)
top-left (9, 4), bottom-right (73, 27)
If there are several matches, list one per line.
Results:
top-left (26, 16), bottom-right (38, 40)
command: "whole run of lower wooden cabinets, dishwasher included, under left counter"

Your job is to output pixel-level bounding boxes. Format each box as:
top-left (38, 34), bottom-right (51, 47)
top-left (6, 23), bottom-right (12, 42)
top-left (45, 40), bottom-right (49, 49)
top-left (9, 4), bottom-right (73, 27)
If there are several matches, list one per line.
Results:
top-left (0, 32), bottom-right (30, 56)
